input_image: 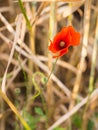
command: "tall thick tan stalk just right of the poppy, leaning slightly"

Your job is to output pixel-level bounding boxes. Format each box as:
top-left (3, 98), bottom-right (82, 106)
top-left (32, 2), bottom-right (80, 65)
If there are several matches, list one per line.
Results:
top-left (70, 0), bottom-right (91, 109)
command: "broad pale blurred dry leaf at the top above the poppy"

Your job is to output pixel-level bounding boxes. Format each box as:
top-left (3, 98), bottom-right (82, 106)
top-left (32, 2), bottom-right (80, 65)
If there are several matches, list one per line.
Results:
top-left (36, 0), bottom-right (85, 24)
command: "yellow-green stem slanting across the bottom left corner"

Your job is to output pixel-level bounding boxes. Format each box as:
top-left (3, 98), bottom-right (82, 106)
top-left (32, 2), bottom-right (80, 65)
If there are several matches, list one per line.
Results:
top-left (0, 90), bottom-right (31, 130)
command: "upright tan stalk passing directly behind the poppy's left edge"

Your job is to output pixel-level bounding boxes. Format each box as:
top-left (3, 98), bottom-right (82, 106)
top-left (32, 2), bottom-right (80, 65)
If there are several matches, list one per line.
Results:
top-left (46, 2), bottom-right (57, 125)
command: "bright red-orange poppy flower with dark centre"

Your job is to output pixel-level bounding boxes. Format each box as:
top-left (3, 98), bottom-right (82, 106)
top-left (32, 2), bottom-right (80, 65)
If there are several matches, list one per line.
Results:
top-left (49, 26), bottom-right (80, 58)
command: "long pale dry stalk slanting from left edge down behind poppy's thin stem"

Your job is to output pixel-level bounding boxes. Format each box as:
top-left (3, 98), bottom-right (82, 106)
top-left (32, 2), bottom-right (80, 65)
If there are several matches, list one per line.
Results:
top-left (0, 33), bottom-right (71, 97)
